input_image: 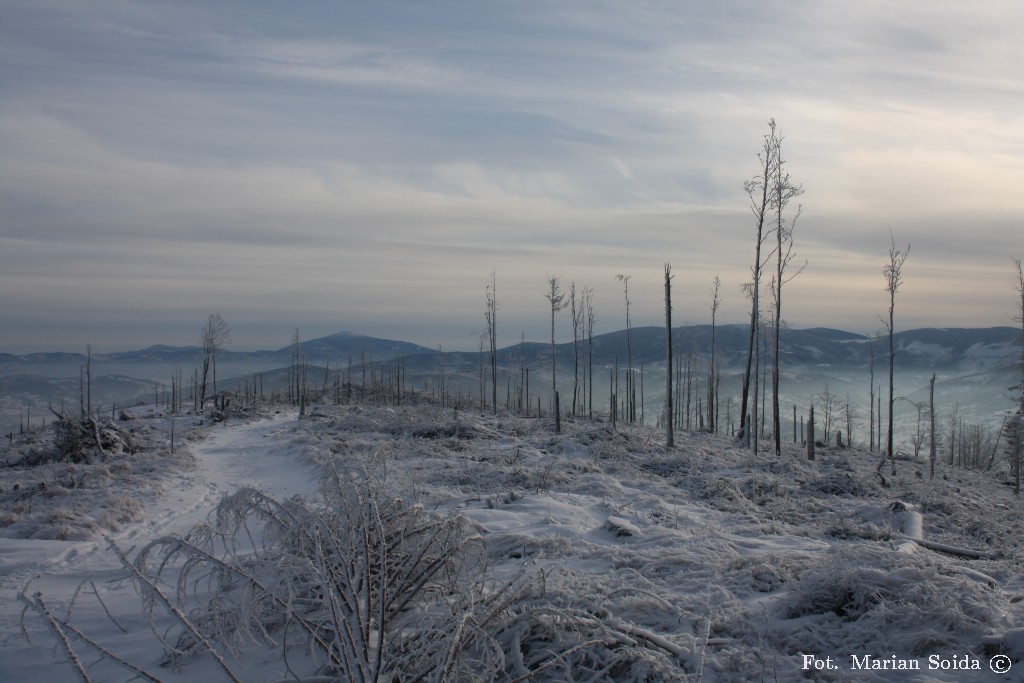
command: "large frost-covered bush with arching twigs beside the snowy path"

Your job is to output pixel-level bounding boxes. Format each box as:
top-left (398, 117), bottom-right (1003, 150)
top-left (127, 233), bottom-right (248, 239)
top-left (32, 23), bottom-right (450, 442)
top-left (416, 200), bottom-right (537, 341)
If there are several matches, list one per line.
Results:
top-left (134, 468), bottom-right (491, 681)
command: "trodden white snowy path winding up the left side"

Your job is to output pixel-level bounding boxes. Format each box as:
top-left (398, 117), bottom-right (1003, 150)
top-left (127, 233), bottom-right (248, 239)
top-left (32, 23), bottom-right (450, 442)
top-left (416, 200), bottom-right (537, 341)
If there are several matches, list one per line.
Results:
top-left (0, 412), bottom-right (317, 682)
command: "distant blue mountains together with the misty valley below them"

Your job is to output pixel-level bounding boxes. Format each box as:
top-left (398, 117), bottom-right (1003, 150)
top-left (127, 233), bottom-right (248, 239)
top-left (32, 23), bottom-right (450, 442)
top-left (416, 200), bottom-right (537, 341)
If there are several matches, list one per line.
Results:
top-left (0, 325), bottom-right (1020, 434)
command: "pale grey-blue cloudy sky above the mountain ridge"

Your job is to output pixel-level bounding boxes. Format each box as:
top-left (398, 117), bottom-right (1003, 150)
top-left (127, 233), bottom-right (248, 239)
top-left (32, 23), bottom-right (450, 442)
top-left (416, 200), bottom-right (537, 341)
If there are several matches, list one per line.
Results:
top-left (0, 0), bottom-right (1024, 351)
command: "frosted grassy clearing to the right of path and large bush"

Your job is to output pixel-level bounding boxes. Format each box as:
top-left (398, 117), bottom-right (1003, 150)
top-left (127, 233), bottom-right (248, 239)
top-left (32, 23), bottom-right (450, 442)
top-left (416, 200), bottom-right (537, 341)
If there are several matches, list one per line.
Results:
top-left (286, 403), bottom-right (1021, 680)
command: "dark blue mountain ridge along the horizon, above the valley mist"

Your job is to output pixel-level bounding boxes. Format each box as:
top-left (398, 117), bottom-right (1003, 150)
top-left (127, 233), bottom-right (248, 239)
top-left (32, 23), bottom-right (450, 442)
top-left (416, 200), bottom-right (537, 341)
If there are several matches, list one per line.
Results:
top-left (0, 325), bottom-right (1021, 372)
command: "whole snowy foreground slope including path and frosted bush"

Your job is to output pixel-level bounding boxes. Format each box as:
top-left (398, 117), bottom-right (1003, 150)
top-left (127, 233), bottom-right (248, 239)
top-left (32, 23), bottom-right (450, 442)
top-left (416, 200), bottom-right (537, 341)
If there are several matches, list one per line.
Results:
top-left (0, 405), bottom-right (1024, 682)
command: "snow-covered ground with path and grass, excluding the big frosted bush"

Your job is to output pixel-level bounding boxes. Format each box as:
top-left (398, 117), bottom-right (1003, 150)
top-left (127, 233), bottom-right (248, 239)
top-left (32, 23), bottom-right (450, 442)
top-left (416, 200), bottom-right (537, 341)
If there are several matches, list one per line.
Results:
top-left (0, 405), bottom-right (1024, 682)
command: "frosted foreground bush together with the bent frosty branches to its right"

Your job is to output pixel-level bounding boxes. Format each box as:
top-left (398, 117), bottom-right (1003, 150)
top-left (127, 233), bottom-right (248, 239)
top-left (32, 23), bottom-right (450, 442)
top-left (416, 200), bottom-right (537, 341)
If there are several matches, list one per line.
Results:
top-left (121, 464), bottom-right (696, 681)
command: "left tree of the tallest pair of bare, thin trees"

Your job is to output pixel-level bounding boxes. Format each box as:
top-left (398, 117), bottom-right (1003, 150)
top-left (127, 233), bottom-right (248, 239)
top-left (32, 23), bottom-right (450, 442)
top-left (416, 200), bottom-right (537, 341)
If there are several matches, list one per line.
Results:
top-left (739, 119), bottom-right (778, 442)
